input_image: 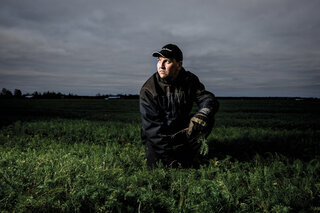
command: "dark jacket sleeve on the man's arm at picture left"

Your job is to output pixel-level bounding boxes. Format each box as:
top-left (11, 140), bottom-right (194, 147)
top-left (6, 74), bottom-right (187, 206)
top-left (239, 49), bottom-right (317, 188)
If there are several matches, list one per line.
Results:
top-left (140, 89), bottom-right (170, 154)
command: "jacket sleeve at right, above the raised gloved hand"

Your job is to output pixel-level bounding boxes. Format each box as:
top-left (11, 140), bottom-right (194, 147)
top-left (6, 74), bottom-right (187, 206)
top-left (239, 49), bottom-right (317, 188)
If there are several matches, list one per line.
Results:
top-left (194, 76), bottom-right (219, 118)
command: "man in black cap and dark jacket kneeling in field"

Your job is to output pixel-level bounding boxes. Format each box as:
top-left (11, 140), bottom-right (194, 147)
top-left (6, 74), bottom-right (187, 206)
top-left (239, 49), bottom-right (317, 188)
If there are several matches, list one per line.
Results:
top-left (140, 44), bottom-right (219, 167)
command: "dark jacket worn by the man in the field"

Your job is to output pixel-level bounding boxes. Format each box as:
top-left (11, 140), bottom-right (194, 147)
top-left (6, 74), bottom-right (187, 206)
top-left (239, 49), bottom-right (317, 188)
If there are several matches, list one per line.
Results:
top-left (140, 68), bottom-right (218, 166)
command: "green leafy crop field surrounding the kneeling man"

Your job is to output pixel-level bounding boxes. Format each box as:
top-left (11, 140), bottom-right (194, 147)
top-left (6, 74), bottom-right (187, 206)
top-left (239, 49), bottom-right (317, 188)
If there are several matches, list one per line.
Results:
top-left (0, 99), bottom-right (320, 212)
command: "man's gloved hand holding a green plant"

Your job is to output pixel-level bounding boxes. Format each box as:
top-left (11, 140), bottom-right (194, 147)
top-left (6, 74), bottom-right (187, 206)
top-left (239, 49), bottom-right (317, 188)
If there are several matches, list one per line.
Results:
top-left (187, 110), bottom-right (208, 137)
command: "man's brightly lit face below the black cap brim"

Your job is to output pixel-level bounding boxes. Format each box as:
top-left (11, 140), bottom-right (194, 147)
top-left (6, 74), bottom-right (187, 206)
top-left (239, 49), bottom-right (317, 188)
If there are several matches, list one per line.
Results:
top-left (157, 57), bottom-right (182, 80)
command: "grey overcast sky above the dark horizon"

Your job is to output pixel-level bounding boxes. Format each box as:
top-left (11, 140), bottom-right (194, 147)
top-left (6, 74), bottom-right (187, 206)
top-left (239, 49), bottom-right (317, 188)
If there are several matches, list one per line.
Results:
top-left (0, 0), bottom-right (320, 97)
